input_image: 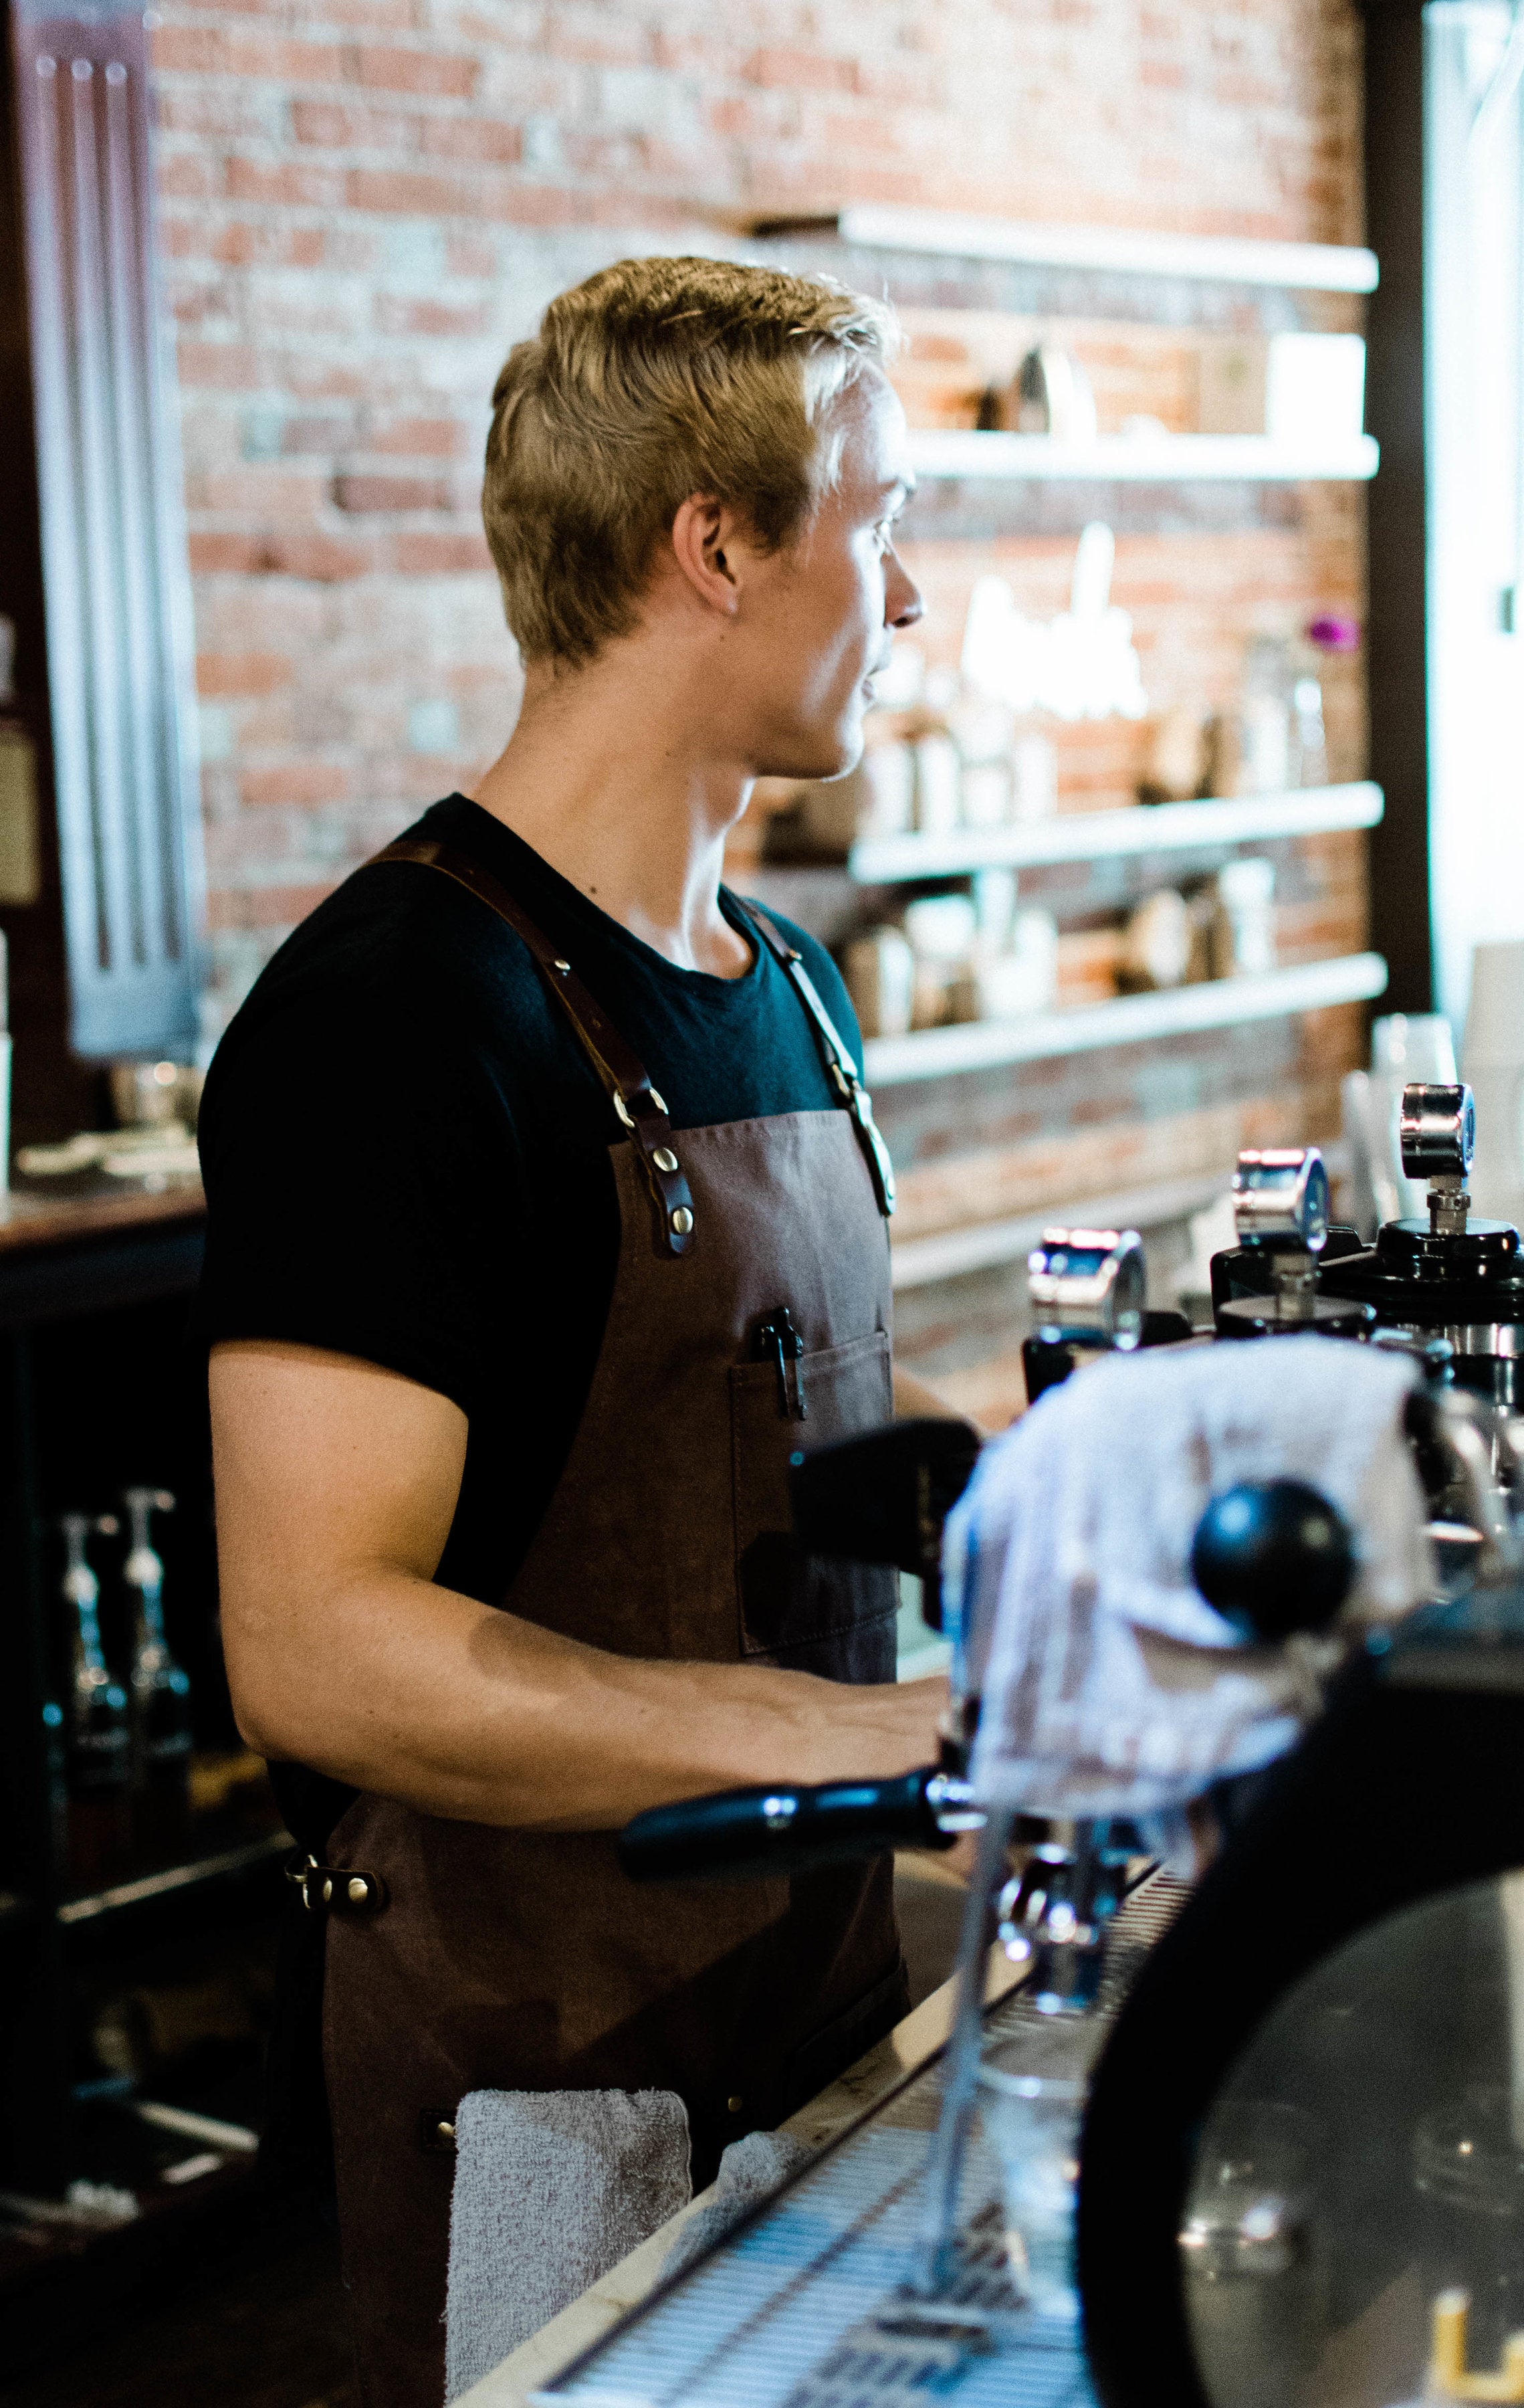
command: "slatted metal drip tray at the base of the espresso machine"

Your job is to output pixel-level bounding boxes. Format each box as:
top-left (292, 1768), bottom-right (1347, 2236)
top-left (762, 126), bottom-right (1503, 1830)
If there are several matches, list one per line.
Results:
top-left (534, 1874), bottom-right (1187, 2408)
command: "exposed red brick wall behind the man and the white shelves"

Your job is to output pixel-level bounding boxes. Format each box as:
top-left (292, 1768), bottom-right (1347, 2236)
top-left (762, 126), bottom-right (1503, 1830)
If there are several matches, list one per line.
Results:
top-left (154, 0), bottom-right (1365, 1406)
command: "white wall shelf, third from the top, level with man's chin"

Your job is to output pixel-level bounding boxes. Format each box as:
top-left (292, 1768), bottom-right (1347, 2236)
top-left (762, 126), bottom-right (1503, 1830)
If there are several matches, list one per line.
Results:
top-left (847, 780), bottom-right (1384, 886)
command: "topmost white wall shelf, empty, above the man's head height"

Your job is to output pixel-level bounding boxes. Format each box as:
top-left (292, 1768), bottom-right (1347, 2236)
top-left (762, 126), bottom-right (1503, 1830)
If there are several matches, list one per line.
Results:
top-left (751, 202), bottom-right (1380, 294)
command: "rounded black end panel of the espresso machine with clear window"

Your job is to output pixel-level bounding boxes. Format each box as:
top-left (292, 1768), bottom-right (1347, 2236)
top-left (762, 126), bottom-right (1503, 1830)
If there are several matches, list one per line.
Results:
top-left (1076, 1502), bottom-right (1524, 2408)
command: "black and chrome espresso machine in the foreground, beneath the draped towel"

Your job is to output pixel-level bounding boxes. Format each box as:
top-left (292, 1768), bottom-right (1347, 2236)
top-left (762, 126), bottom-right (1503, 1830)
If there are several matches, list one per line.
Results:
top-left (963, 1156), bottom-right (1524, 2408)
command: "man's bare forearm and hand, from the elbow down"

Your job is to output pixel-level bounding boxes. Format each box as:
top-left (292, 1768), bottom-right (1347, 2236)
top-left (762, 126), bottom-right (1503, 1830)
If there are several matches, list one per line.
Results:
top-left (231, 1573), bottom-right (942, 1830)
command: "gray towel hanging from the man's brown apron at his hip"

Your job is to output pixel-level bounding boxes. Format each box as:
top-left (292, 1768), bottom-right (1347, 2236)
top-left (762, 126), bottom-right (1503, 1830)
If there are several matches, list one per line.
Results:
top-left (445, 2090), bottom-right (691, 2401)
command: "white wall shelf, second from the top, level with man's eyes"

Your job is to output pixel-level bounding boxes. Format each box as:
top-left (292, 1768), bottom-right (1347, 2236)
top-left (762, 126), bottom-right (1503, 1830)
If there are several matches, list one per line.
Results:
top-left (910, 426), bottom-right (1382, 484)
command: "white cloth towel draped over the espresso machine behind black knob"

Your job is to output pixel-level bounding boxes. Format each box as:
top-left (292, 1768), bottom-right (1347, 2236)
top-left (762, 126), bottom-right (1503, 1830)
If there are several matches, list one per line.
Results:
top-left (946, 1336), bottom-right (1430, 1815)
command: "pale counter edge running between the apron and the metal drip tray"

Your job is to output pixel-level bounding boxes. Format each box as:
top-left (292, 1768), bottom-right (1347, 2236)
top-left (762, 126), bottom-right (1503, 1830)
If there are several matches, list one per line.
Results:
top-left (455, 1948), bottom-right (1021, 2408)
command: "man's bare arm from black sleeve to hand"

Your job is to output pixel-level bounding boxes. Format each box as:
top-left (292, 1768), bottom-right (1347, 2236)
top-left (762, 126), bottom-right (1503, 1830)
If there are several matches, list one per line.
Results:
top-left (212, 1341), bottom-right (944, 1830)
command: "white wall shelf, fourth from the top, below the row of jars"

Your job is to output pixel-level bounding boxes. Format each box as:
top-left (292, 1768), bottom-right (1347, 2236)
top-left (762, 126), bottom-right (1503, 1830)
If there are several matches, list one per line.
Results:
top-left (865, 954), bottom-right (1387, 1088)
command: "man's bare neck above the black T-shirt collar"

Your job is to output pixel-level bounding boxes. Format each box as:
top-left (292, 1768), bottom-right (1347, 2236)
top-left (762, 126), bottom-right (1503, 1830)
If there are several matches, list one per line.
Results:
top-left (472, 647), bottom-right (751, 978)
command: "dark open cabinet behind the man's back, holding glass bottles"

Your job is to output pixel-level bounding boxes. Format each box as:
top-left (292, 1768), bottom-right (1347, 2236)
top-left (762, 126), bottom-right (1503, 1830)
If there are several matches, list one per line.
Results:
top-left (0, 1189), bottom-right (292, 2350)
